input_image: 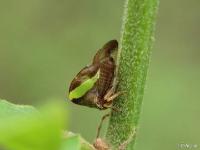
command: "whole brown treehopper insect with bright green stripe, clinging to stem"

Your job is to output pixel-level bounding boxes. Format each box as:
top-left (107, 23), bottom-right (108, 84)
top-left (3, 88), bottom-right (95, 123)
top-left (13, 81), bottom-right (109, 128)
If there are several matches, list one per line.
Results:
top-left (69, 40), bottom-right (121, 110)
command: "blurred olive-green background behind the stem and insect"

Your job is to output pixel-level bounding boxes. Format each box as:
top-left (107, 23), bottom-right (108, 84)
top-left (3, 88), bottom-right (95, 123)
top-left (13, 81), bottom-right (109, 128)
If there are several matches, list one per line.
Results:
top-left (0, 0), bottom-right (200, 150)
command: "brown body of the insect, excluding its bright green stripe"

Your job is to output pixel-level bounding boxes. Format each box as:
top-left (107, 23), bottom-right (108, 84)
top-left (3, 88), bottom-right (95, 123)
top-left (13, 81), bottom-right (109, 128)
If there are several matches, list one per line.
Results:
top-left (69, 40), bottom-right (118, 109)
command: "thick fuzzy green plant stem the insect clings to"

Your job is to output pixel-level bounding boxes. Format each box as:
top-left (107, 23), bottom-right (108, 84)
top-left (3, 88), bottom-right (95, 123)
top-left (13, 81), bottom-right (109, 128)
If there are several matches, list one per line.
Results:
top-left (106, 0), bottom-right (159, 150)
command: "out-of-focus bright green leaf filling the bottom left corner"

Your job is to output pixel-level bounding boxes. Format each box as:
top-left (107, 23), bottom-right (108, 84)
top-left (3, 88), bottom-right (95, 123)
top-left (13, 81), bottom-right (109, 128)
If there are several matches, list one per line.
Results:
top-left (0, 100), bottom-right (66, 150)
